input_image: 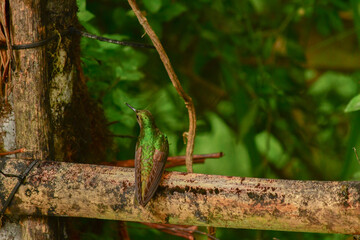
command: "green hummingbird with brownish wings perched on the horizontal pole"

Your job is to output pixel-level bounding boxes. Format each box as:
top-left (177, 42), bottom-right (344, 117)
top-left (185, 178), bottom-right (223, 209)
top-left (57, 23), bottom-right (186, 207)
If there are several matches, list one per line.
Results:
top-left (125, 103), bottom-right (169, 207)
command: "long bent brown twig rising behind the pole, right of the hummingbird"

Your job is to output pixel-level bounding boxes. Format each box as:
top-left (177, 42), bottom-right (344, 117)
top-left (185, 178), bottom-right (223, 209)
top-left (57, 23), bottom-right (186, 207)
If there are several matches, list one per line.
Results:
top-left (128, 0), bottom-right (196, 172)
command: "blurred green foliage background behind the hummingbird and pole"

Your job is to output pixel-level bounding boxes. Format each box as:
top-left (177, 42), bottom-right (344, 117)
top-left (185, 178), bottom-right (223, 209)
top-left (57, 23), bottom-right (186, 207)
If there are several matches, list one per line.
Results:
top-left (74, 0), bottom-right (360, 240)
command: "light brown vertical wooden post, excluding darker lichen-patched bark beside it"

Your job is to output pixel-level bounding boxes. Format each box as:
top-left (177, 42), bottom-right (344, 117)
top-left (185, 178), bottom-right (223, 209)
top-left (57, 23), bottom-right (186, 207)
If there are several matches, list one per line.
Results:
top-left (6, 0), bottom-right (63, 240)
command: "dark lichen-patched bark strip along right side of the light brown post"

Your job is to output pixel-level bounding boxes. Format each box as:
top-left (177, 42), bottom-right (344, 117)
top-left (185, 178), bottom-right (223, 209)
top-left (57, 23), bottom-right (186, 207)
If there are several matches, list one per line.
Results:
top-left (44, 0), bottom-right (79, 161)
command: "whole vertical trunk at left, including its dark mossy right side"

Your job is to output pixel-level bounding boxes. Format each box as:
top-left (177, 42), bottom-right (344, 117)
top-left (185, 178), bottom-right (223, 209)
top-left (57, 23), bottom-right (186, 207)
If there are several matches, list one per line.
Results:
top-left (0, 0), bottom-right (109, 240)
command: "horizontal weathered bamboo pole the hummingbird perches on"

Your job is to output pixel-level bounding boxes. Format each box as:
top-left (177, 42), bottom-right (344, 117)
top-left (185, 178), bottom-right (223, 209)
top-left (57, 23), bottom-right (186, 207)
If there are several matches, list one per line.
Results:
top-left (0, 159), bottom-right (360, 234)
